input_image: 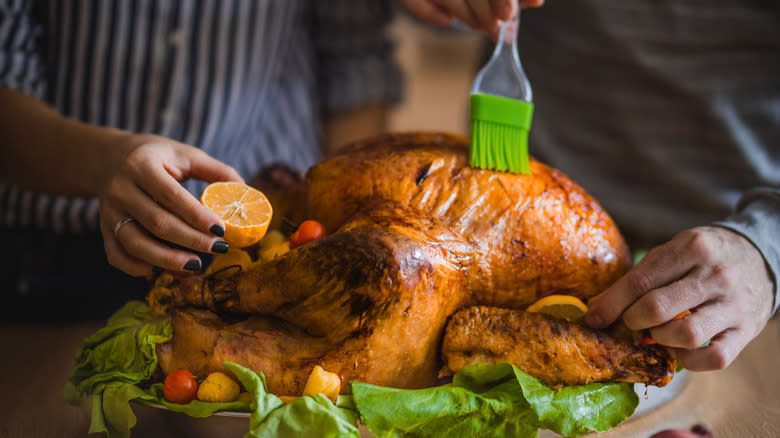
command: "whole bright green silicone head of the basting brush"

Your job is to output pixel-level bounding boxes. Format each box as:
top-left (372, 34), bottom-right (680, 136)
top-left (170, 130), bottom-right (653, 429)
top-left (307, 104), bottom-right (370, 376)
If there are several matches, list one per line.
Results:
top-left (470, 94), bottom-right (534, 173)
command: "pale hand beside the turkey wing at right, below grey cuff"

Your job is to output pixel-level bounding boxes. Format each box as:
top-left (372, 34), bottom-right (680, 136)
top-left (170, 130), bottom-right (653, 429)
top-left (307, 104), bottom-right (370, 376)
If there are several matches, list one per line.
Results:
top-left (586, 227), bottom-right (775, 371)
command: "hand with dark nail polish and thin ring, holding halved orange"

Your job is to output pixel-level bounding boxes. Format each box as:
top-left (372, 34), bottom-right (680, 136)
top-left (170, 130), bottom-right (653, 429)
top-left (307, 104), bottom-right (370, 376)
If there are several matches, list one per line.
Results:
top-left (98, 134), bottom-right (242, 276)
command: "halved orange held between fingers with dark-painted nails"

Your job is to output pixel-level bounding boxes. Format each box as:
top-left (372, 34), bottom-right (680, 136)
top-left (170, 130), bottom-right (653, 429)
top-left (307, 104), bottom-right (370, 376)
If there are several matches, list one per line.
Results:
top-left (200, 182), bottom-right (273, 248)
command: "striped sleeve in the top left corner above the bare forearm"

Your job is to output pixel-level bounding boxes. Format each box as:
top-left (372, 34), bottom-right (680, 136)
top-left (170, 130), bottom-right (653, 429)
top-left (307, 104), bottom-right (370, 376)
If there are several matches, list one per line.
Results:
top-left (0, 0), bottom-right (45, 98)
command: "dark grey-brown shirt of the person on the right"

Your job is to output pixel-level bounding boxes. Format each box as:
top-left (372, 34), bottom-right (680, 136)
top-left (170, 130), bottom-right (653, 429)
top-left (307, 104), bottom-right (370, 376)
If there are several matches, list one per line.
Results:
top-left (520, 0), bottom-right (780, 314)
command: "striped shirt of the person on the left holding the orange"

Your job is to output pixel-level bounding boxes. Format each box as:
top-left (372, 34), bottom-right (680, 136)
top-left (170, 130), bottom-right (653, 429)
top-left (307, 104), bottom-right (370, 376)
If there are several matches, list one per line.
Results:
top-left (0, 0), bottom-right (400, 233)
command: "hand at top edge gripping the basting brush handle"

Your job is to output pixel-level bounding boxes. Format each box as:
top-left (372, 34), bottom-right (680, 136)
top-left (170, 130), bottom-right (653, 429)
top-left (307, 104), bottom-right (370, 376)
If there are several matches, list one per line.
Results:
top-left (401, 0), bottom-right (544, 35)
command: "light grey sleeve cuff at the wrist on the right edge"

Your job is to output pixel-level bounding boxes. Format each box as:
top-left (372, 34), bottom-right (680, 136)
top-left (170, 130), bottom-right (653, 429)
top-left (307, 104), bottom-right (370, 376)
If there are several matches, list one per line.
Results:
top-left (715, 188), bottom-right (780, 313)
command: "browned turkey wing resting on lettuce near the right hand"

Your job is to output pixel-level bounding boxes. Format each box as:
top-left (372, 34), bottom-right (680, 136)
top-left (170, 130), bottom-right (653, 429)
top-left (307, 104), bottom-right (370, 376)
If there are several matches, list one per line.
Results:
top-left (442, 306), bottom-right (675, 386)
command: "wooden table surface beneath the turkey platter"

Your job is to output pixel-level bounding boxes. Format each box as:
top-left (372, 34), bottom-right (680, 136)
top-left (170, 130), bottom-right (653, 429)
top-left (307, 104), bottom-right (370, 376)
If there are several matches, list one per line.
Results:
top-left (0, 318), bottom-right (780, 438)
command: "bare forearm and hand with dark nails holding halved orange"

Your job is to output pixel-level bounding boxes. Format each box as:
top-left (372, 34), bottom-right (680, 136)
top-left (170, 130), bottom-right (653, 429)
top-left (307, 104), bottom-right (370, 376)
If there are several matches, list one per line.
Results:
top-left (0, 88), bottom-right (240, 275)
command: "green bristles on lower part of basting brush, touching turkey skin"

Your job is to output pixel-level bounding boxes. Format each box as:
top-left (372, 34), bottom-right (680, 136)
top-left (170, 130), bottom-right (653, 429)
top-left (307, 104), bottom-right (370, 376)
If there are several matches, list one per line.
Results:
top-left (471, 120), bottom-right (531, 174)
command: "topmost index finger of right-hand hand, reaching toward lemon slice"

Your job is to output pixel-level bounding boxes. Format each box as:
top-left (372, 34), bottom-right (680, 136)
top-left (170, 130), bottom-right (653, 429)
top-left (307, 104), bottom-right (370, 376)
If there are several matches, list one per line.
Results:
top-left (585, 239), bottom-right (693, 328)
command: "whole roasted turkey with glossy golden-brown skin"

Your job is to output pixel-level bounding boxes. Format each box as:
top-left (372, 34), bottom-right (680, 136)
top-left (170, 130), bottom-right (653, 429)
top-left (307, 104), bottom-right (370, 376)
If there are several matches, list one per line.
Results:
top-left (149, 134), bottom-right (673, 394)
